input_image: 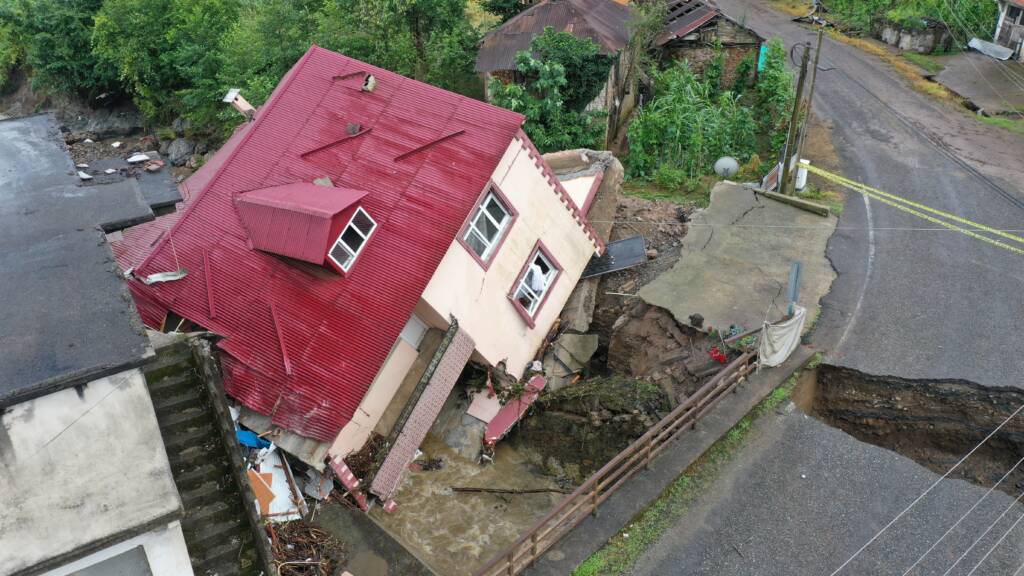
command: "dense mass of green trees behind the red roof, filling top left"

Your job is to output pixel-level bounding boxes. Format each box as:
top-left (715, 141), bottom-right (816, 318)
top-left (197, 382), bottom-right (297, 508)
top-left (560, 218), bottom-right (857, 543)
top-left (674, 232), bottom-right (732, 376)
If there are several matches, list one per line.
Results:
top-left (0, 0), bottom-right (482, 135)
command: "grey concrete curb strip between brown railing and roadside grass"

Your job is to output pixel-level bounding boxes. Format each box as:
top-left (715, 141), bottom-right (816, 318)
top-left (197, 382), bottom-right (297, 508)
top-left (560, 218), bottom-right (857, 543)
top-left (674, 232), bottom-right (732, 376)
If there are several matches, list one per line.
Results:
top-left (523, 345), bottom-right (816, 576)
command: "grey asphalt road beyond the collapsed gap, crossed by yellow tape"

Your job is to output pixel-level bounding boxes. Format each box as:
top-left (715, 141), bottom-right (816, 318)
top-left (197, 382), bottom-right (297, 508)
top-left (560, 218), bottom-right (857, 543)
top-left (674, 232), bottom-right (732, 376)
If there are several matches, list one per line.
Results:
top-left (717, 0), bottom-right (1024, 387)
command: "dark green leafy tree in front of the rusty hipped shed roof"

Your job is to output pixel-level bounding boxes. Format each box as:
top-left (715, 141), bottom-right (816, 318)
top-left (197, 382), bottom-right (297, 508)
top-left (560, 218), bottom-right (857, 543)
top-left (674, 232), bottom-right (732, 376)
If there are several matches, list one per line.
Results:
top-left (529, 27), bottom-right (611, 112)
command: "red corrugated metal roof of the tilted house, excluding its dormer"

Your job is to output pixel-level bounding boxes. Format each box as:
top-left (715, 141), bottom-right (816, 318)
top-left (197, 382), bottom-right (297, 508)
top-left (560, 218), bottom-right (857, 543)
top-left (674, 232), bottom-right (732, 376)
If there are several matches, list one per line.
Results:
top-left (124, 46), bottom-right (523, 441)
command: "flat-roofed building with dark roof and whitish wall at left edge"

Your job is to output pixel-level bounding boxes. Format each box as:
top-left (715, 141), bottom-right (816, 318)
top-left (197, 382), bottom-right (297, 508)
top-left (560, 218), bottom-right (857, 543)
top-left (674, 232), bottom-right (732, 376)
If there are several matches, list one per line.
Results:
top-left (0, 116), bottom-right (193, 576)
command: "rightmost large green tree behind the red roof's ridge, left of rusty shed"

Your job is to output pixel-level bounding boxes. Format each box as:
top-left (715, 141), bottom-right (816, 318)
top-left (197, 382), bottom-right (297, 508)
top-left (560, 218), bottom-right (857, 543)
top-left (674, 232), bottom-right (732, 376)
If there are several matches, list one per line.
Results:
top-left (316, 0), bottom-right (479, 89)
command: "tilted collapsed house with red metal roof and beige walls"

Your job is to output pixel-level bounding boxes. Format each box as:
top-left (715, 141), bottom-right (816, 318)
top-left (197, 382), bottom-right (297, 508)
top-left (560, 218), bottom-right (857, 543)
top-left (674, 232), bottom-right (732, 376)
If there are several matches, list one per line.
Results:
top-left (115, 46), bottom-right (603, 498)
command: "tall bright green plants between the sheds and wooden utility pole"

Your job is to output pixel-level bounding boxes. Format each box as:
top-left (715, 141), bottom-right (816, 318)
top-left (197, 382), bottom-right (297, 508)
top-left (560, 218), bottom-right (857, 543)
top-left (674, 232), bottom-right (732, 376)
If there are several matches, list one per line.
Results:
top-left (626, 39), bottom-right (794, 194)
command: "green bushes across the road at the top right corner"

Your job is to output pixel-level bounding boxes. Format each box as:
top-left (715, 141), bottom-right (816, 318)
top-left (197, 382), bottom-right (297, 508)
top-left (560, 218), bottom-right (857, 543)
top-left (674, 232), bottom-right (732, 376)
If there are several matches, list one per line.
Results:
top-left (827, 0), bottom-right (998, 43)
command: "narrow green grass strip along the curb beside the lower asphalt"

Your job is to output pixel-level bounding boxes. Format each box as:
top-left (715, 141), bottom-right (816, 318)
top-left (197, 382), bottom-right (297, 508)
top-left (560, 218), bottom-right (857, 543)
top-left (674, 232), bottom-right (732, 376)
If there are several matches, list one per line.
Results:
top-left (572, 364), bottom-right (802, 576)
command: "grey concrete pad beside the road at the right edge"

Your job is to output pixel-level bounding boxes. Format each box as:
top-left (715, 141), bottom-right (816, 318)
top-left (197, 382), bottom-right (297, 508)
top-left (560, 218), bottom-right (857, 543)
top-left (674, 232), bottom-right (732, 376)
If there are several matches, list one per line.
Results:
top-left (935, 51), bottom-right (1024, 114)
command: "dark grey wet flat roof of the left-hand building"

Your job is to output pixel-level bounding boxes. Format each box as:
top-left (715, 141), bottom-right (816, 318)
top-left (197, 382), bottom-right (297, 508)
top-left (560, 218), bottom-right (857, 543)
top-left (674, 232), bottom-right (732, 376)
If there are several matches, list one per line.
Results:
top-left (0, 115), bottom-right (151, 405)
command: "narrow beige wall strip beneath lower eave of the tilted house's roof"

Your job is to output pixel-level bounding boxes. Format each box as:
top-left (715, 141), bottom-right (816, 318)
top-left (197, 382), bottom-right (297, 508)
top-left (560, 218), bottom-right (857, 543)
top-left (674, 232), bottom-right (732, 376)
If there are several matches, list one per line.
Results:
top-left (328, 337), bottom-right (419, 457)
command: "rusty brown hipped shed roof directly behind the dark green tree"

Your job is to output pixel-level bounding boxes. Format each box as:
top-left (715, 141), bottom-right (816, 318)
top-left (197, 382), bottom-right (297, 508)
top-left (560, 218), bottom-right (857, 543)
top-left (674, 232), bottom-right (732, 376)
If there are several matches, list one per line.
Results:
top-left (475, 0), bottom-right (630, 72)
